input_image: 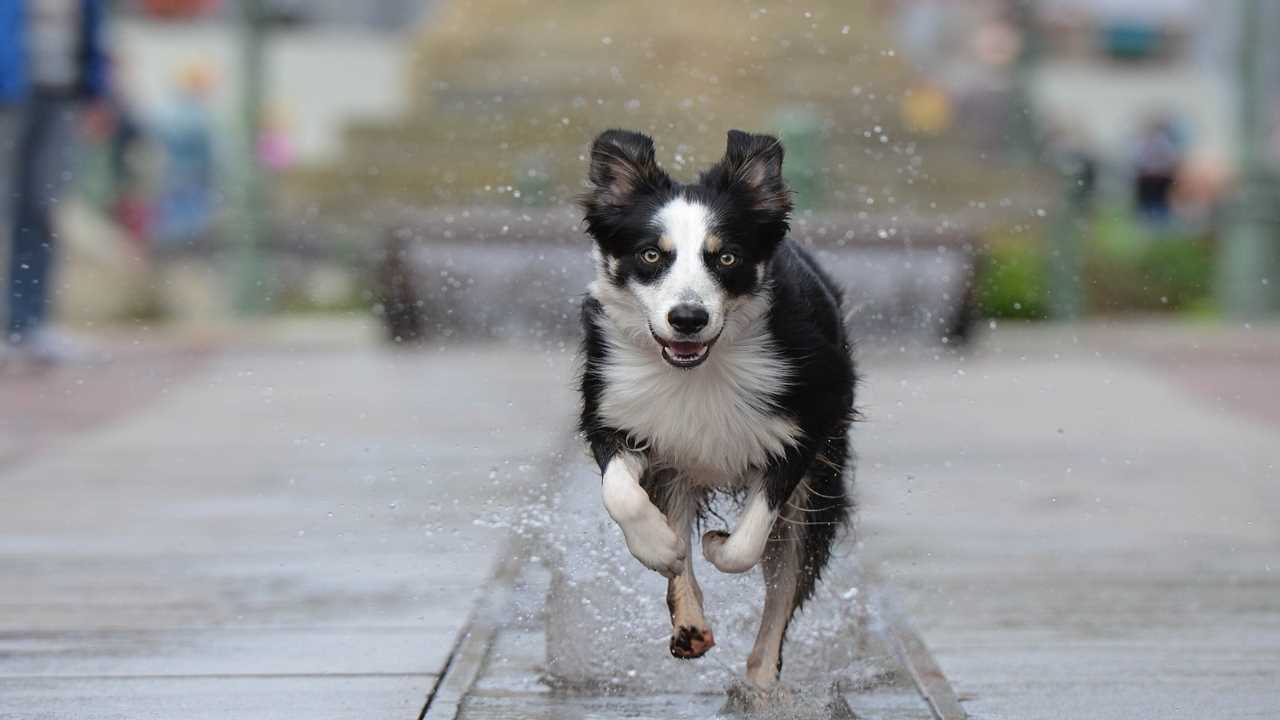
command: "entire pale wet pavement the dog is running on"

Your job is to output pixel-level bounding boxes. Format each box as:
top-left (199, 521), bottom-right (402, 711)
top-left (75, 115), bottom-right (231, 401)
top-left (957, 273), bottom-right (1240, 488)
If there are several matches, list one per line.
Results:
top-left (0, 323), bottom-right (1280, 720)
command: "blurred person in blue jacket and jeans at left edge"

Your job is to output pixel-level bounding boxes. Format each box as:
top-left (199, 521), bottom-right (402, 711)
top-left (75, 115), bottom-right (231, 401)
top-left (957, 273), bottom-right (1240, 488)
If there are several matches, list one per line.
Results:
top-left (0, 0), bottom-right (106, 363)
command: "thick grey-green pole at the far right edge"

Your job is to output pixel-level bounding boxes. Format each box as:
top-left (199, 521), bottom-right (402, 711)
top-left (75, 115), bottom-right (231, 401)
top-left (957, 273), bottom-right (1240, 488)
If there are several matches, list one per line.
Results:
top-left (1217, 0), bottom-right (1280, 318)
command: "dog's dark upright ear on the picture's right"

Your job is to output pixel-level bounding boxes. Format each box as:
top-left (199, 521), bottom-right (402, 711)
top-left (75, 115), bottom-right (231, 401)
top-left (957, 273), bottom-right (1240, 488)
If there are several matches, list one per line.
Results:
top-left (703, 129), bottom-right (791, 222)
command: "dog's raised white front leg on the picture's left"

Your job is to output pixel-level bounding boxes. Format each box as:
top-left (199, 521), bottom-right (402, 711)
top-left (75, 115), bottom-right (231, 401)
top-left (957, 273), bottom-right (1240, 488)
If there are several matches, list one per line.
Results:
top-left (602, 452), bottom-right (689, 578)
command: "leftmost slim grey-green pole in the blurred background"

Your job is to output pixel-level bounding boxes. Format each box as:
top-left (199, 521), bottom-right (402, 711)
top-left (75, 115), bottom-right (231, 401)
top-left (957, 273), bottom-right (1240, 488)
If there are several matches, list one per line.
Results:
top-left (236, 0), bottom-right (268, 315)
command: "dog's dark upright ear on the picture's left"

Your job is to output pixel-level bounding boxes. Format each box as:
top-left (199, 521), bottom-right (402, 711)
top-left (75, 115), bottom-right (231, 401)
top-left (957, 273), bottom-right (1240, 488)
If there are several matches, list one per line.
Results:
top-left (582, 129), bottom-right (671, 204)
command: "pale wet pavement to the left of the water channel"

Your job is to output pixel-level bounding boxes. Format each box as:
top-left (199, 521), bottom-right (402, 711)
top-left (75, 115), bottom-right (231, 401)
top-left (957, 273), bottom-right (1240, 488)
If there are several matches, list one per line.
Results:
top-left (0, 340), bottom-right (572, 719)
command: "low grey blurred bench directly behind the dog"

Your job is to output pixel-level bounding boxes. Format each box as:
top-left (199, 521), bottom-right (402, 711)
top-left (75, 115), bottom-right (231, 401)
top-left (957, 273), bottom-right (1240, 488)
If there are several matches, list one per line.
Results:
top-left (376, 208), bottom-right (978, 343)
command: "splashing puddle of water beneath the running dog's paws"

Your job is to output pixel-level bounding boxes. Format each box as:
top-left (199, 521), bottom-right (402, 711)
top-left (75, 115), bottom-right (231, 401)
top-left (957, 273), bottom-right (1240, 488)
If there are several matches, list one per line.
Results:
top-left (494, 461), bottom-right (908, 696)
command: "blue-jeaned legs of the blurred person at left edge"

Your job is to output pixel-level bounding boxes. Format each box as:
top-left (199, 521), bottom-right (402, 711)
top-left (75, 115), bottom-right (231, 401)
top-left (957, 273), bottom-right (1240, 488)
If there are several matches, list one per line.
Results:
top-left (6, 97), bottom-right (73, 343)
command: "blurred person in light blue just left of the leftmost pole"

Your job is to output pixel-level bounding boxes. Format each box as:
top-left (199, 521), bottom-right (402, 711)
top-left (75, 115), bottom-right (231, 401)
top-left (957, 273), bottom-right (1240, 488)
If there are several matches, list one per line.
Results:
top-left (156, 63), bottom-right (215, 247)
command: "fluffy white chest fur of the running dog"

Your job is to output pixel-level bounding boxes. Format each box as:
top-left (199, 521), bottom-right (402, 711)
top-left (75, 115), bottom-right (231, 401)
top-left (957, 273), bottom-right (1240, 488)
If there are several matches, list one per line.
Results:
top-left (600, 307), bottom-right (799, 486)
